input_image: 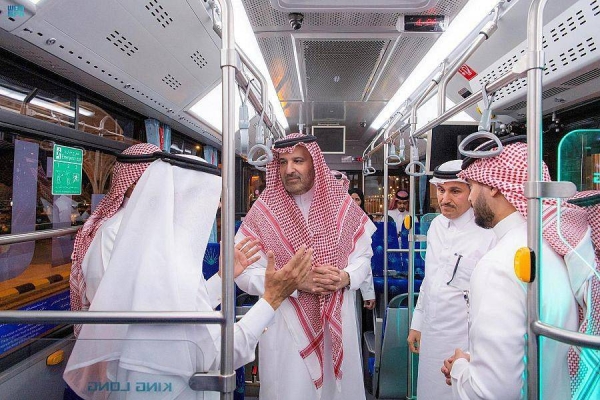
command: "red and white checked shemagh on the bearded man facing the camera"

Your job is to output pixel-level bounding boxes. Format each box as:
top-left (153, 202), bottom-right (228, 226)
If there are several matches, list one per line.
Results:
top-left (240, 133), bottom-right (369, 390)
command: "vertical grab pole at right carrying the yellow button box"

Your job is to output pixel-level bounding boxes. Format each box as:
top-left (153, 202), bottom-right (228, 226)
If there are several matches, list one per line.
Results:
top-left (527, 0), bottom-right (546, 399)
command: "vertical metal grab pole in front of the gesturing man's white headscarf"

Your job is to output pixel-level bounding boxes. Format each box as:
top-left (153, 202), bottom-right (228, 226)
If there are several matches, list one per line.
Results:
top-left (219, 0), bottom-right (233, 399)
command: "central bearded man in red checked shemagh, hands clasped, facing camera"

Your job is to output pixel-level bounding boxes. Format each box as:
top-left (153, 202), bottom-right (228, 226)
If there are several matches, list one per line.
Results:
top-left (236, 134), bottom-right (375, 400)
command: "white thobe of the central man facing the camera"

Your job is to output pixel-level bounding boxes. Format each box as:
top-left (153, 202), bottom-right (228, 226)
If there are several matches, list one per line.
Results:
top-left (236, 188), bottom-right (375, 400)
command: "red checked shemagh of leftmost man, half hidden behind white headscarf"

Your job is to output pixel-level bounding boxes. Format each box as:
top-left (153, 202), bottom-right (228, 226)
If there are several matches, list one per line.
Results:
top-left (69, 143), bottom-right (160, 335)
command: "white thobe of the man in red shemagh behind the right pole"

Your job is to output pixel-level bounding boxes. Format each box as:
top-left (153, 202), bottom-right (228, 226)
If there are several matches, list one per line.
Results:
top-left (451, 212), bottom-right (594, 400)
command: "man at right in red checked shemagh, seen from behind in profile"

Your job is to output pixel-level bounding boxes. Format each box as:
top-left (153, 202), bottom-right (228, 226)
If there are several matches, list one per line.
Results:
top-left (442, 143), bottom-right (594, 399)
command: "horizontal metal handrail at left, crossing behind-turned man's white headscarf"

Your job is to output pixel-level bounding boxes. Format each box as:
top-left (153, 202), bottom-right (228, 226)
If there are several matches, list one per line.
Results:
top-left (0, 310), bottom-right (225, 324)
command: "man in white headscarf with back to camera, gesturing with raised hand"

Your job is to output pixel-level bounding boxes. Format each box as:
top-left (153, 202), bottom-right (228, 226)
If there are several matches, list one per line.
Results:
top-left (64, 152), bottom-right (312, 399)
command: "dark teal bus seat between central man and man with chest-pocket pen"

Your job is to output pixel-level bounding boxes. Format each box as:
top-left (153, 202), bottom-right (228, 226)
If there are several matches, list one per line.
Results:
top-left (373, 293), bottom-right (418, 399)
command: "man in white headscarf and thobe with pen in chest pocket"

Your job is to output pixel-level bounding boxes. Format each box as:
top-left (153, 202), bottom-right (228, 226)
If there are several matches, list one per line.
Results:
top-left (407, 160), bottom-right (496, 400)
